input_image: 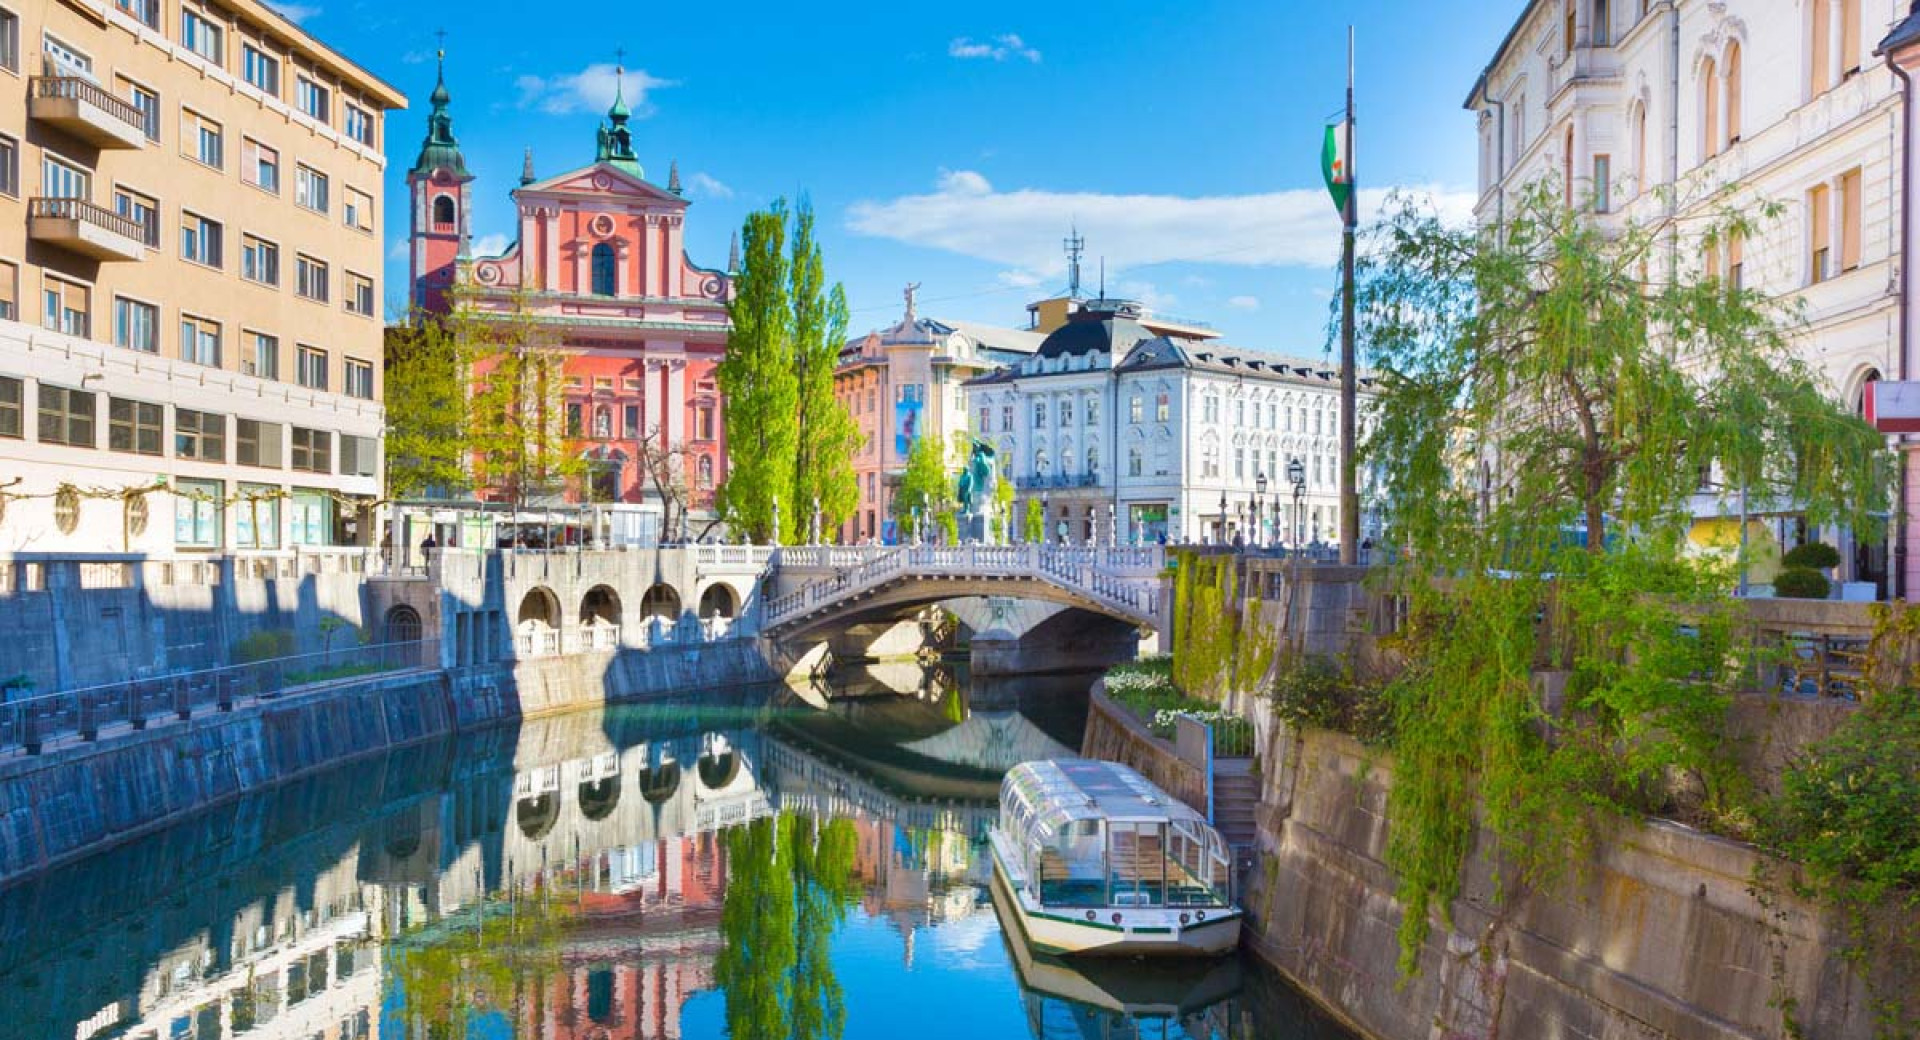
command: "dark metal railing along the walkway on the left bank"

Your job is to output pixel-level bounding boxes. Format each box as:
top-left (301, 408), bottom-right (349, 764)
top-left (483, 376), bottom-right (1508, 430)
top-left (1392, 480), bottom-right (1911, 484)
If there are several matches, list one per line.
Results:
top-left (0, 639), bottom-right (440, 754)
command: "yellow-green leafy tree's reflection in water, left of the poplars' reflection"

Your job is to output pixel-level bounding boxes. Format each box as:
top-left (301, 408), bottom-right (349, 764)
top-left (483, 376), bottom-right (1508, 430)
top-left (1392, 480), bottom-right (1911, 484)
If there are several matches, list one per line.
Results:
top-left (380, 886), bottom-right (574, 1040)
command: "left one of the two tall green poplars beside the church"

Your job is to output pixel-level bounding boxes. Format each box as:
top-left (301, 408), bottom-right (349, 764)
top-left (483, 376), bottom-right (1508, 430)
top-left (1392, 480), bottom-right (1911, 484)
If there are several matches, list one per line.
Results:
top-left (718, 200), bottom-right (810, 543)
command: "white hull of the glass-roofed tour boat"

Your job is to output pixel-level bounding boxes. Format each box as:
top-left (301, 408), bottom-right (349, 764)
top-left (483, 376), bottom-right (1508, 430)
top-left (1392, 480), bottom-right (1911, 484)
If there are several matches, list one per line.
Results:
top-left (989, 831), bottom-right (1240, 957)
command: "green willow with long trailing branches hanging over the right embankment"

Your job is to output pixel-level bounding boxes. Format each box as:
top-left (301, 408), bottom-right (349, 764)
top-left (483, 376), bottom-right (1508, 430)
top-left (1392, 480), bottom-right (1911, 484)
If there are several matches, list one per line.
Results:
top-left (1357, 184), bottom-right (1889, 973)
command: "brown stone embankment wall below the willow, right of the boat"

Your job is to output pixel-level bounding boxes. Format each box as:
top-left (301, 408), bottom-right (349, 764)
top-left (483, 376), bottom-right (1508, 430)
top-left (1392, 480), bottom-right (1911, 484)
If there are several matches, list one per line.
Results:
top-left (1246, 698), bottom-right (1910, 1040)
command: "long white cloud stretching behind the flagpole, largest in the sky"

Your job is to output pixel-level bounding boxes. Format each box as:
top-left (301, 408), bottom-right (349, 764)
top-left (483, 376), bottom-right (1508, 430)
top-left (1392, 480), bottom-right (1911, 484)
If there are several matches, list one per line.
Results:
top-left (847, 171), bottom-right (1475, 280)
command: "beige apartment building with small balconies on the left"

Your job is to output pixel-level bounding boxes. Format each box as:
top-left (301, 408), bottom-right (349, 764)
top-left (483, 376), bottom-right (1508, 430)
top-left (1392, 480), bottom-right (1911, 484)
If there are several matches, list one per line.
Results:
top-left (0, 0), bottom-right (405, 555)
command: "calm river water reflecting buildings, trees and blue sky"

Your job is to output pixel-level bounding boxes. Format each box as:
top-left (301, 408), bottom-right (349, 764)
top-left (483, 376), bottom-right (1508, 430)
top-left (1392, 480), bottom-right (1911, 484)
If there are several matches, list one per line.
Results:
top-left (0, 666), bottom-right (1350, 1040)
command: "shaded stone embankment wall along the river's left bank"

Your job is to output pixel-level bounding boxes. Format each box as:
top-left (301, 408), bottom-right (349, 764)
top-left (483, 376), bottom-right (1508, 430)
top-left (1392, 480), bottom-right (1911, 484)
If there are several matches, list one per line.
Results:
top-left (0, 639), bottom-right (774, 883)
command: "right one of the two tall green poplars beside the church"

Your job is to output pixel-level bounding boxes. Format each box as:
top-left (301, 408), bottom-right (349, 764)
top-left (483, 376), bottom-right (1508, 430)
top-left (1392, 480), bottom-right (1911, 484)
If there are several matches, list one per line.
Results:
top-left (785, 200), bottom-right (860, 537)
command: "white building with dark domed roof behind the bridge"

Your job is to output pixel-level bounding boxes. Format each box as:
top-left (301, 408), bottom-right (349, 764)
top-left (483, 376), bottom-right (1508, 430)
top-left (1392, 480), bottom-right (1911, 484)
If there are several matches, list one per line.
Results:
top-left (966, 299), bottom-right (1379, 545)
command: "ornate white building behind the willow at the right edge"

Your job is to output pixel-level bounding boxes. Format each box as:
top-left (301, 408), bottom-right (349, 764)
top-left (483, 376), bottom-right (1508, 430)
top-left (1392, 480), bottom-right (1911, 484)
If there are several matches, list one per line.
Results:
top-left (1467, 0), bottom-right (1905, 595)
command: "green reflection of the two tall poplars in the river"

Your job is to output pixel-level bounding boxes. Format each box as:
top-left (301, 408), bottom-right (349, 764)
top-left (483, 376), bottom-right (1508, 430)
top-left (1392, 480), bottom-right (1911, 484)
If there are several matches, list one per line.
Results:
top-left (714, 814), bottom-right (858, 1040)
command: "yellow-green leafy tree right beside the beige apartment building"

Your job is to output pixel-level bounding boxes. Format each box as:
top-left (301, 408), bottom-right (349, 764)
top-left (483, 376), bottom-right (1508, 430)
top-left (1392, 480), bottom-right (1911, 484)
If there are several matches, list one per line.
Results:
top-left (384, 315), bottom-right (472, 499)
